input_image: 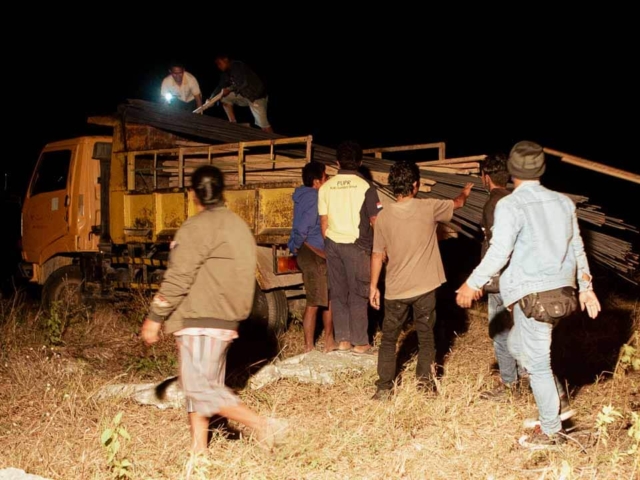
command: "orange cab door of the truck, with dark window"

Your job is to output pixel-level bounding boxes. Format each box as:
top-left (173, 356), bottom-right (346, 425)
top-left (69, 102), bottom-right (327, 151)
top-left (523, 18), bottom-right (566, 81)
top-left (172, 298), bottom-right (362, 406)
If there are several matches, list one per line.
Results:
top-left (22, 146), bottom-right (77, 262)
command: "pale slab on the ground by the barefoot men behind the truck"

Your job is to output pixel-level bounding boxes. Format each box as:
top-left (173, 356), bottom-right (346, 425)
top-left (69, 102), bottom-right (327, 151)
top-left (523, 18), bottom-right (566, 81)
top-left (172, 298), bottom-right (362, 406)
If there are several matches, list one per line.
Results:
top-left (249, 350), bottom-right (378, 390)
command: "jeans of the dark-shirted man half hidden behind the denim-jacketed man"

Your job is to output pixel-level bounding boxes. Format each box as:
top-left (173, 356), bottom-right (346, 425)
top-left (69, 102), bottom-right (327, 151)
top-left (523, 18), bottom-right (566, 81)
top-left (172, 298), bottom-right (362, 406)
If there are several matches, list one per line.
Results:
top-left (488, 293), bottom-right (525, 384)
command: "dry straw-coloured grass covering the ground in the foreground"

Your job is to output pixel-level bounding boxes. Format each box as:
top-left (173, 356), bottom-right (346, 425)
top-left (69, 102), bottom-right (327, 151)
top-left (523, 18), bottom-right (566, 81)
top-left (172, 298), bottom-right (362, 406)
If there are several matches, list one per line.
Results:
top-left (0, 284), bottom-right (640, 480)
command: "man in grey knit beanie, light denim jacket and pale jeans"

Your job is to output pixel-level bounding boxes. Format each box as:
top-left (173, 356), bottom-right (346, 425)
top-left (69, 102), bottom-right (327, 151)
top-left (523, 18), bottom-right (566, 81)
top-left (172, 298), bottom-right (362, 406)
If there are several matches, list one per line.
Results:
top-left (456, 141), bottom-right (600, 447)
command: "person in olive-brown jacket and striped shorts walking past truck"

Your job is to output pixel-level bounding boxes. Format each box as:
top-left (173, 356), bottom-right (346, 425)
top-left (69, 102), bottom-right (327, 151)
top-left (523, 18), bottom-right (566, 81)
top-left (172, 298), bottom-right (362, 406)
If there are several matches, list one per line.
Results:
top-left (141, 165), bottom-right (287, 454)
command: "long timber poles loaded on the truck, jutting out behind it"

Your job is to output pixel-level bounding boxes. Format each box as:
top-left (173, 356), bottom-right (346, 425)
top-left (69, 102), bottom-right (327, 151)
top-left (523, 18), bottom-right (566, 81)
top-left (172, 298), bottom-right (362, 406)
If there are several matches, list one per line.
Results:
top-left (118, 100), bottom-right (640, 285)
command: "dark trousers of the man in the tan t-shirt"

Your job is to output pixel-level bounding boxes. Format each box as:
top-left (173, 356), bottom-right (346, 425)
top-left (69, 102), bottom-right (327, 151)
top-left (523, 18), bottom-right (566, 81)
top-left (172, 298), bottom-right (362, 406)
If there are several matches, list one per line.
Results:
top-left (376, 290), bottom-right (436, 390)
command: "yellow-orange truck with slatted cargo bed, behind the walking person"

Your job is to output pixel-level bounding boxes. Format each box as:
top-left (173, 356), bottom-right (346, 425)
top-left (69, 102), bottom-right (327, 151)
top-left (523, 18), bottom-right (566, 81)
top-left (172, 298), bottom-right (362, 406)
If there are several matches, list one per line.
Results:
top-left (21, 103), bottom-right (312, 329)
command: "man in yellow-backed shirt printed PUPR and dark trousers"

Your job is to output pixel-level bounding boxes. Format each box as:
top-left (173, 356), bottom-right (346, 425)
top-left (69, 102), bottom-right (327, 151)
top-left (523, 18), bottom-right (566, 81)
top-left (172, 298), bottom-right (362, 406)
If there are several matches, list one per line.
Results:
top-left (318, 141), bottom-right (382, 354)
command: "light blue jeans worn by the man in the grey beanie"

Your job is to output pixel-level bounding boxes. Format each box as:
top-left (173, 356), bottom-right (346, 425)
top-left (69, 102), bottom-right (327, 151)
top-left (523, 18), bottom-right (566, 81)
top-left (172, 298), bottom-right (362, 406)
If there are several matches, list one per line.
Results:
top-left (508, 303), bottom-right (562, 435)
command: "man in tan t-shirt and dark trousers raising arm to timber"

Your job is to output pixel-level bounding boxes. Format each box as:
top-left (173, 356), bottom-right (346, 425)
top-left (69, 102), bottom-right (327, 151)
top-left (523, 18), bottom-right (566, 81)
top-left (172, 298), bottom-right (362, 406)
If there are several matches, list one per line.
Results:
top-left (369, 161), bottom-right (473, 400)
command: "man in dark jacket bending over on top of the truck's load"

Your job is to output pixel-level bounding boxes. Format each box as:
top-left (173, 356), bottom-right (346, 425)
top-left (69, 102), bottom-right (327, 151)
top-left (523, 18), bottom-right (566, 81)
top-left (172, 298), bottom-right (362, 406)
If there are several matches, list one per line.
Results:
top-left (210, 54), bottom-right (273, 133)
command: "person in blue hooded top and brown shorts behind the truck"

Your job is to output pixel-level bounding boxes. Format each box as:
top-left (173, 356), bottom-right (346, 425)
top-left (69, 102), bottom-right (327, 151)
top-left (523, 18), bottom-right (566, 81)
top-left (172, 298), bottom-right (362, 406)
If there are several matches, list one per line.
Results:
top-left (288, 162), bottom-right (335, 352)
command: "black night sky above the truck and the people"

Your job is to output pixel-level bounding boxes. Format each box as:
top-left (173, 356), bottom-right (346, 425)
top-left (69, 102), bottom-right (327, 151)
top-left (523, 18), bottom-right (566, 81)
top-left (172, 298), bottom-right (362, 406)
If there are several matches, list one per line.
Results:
top-left (1, 9), bottom-right (640, 286)
